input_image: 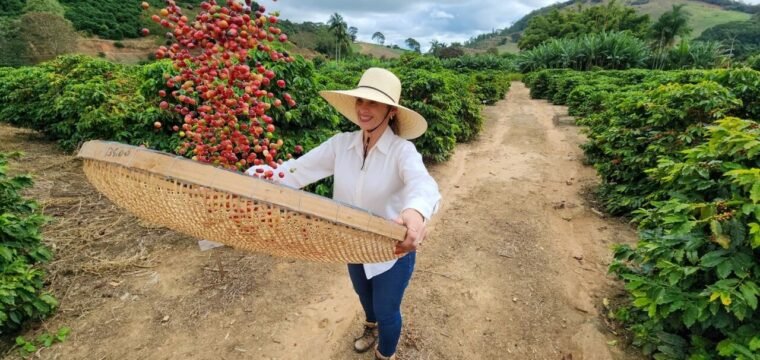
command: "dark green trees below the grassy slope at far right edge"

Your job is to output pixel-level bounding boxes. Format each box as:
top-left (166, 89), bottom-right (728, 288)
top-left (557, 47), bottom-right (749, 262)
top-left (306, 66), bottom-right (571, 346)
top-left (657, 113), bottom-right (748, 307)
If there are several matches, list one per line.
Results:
top-left (697, 20), bottom-right (760, 60)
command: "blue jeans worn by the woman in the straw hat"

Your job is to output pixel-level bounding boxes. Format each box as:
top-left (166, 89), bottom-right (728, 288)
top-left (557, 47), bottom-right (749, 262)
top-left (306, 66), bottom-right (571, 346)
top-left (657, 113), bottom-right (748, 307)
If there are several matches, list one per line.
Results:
top-left (348, 251), bottom-right (416, 356)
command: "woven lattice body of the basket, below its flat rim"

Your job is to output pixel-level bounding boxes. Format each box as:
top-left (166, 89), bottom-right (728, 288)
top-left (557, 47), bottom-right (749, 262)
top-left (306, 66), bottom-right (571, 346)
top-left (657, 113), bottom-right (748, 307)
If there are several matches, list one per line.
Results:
top-left (84, 158), bottom-right (397, 263)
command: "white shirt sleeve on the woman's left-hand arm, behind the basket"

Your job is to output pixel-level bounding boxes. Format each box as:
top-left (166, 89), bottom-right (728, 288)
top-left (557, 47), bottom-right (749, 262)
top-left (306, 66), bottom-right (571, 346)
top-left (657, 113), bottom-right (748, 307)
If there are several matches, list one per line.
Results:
top-left (245, 135), bottom-right (339, 189)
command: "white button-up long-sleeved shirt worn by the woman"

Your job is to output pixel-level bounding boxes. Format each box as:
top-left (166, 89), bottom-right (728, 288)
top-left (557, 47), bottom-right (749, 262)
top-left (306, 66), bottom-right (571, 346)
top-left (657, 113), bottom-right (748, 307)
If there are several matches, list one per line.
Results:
top-left (247, 127), bottom-right (441, 279)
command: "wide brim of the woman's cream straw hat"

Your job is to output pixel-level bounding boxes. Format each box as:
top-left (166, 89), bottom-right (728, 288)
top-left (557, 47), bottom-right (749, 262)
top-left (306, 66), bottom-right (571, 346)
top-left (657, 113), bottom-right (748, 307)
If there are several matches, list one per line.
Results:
top-left (319, 88), bottom-right (427, 140)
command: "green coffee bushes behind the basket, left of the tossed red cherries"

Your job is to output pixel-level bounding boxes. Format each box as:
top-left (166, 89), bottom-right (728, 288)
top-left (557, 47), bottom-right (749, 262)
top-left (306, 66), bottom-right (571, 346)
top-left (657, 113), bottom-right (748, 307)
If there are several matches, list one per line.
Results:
top-left (0, 56), bottom-right (178, 150)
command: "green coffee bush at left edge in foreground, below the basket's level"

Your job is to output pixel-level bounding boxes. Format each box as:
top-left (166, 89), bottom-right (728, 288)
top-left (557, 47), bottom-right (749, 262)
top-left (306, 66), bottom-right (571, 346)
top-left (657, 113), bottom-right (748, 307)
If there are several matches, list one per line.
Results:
top-left (0, 153), bottom-right (58, 333)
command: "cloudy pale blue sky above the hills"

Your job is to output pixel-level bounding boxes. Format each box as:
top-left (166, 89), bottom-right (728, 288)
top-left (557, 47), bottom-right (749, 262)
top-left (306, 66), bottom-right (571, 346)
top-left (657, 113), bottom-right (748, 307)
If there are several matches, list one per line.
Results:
top-left (259, 0), bottom-right (760, 51)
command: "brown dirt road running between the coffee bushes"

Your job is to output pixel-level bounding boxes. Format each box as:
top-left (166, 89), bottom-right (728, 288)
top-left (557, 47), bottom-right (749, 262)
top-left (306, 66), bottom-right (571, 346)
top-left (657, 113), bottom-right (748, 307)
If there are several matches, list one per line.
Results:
top-left (0, 83), bottom-right (635, 360)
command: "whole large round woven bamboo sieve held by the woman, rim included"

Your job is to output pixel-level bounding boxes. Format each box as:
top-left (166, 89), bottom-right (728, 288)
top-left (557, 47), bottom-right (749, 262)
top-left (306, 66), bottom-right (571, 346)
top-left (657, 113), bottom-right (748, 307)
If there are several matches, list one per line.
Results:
top-left (78, 140), bottom-right (406, 264)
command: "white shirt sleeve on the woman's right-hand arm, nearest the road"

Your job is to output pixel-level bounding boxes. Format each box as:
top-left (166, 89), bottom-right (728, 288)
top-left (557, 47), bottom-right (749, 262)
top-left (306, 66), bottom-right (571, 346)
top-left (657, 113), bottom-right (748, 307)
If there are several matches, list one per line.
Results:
top-left (399, 142), bottom-right (441, 221)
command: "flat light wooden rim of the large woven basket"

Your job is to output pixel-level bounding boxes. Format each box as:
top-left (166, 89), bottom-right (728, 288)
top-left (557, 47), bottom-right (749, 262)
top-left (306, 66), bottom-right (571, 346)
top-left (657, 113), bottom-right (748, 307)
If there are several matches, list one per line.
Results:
top-left (77, 140), bottom-right (406, 241)
